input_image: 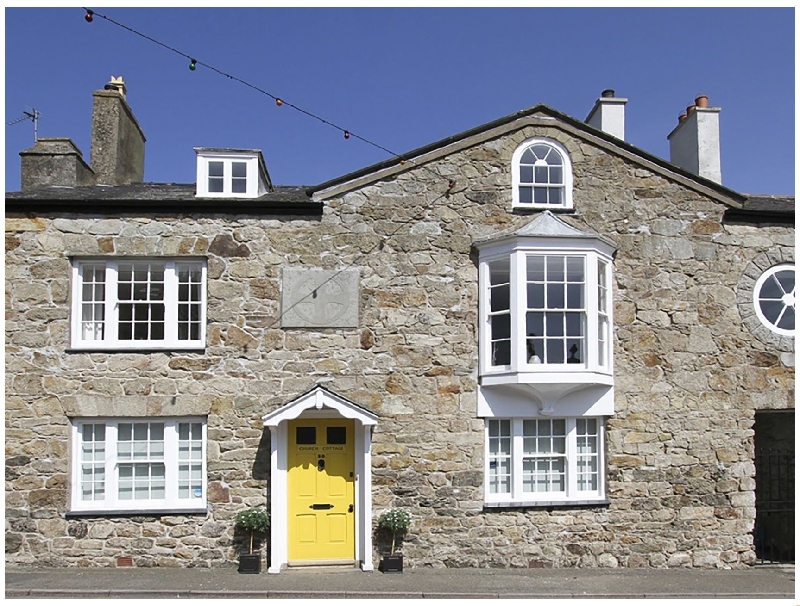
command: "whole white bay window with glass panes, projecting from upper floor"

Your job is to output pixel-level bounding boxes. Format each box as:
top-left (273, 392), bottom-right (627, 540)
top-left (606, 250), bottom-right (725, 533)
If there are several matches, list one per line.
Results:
top-left (481, 242), bottom-right (611, 382)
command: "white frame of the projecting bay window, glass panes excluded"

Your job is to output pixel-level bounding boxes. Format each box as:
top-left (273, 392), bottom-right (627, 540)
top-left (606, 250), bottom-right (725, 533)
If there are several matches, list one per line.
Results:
top-left (479, 238), bottom-right (613, 385)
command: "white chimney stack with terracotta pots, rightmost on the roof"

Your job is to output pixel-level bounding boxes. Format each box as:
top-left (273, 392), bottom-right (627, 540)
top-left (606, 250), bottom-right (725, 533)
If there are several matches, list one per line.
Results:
top-left (667, 95), bottom-right (722, 184)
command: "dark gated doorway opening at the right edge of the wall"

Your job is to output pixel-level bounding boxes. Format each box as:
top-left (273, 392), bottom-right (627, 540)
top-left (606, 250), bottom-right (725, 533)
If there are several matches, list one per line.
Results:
top-left (753, 410), bottom-right (794, 563)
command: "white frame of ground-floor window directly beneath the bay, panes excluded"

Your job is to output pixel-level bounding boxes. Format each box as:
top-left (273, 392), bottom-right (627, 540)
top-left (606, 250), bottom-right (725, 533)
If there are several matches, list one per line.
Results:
top-left (484, 417), bottom-right (607, 507)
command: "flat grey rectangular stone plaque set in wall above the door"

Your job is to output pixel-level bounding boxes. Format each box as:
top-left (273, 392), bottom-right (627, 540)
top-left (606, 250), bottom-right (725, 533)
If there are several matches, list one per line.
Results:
top-left (281, 267), bottom-right (358, 328)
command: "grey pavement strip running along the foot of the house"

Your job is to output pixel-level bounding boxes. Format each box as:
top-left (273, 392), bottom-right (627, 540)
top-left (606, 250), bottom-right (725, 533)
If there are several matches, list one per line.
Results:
top-left (5, 565), bottom-right (798, 604)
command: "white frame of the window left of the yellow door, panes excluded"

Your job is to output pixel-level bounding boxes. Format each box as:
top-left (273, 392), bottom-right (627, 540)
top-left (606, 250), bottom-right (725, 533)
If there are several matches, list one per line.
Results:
top-left (70, 417), bottom-right (208, 513)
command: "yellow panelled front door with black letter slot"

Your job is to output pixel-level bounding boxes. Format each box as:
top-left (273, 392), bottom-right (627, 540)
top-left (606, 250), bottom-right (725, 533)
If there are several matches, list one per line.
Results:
top-left (288, 419), bottom-right (355, 562)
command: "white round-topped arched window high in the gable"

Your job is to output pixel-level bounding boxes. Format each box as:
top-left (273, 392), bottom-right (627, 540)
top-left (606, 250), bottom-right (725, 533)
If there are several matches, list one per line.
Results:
top-left (512, 139), bottom-right (572, 209)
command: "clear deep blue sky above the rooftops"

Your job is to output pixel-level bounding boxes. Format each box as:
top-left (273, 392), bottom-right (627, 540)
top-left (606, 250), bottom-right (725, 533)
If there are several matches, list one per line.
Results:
top-left (5, 6), bottom-right (795, 195)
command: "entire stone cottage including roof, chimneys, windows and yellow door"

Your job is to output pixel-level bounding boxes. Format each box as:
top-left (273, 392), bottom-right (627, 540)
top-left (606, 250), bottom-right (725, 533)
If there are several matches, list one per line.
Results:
top-left (5, 80), bottom-right (794, 572)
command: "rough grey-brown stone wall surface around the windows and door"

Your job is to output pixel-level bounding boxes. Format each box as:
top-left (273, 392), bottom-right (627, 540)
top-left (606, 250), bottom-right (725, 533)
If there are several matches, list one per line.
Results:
top-left (6, 122), bottom-right (794, 567)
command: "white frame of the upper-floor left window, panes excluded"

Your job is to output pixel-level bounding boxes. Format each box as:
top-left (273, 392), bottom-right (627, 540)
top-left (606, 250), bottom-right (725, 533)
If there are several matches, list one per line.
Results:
top-left (71, 257), bottom-right (208, 350)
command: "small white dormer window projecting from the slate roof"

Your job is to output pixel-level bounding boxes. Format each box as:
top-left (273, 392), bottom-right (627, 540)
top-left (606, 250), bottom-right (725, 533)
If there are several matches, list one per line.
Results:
top-left (195, 148), bottom-right (272, 198)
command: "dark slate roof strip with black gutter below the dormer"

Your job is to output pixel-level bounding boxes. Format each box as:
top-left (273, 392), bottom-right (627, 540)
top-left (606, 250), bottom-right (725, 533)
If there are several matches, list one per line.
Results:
top-left (6, 183), bottom-right (322, 214)
